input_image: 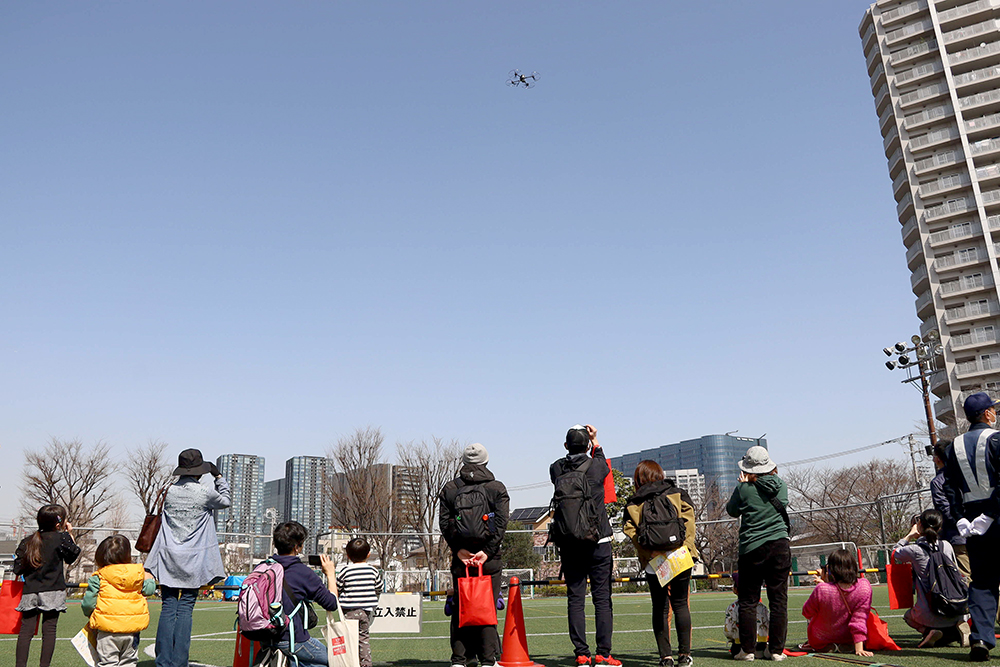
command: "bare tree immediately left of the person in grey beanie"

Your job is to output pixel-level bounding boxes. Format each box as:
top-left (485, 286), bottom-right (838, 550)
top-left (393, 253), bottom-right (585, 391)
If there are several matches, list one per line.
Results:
top-left (393, 437), bottom-right (462, 574)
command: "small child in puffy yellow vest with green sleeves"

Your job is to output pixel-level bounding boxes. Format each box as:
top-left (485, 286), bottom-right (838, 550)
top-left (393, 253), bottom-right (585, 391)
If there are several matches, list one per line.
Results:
top-left (82, 535), bottom-right (156, 667)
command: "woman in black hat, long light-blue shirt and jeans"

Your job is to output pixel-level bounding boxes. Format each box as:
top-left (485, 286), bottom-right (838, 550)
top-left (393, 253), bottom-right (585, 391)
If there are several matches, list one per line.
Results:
top-left (145, 449), bottom-right (232, 667)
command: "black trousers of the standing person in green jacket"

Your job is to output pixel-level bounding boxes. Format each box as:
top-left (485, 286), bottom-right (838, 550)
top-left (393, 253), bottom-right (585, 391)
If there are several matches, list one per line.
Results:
top-left (738, 537), bottom-right (792, 654)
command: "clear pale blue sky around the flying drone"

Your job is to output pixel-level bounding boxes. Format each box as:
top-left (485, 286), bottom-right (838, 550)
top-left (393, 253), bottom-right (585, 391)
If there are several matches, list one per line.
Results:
top-left (0, 0), bottom-right (922, 519)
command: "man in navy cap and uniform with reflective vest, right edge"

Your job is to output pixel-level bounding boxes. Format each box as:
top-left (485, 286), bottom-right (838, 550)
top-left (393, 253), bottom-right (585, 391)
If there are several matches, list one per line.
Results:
top-left (945, 392), bottom-right (1000, 662)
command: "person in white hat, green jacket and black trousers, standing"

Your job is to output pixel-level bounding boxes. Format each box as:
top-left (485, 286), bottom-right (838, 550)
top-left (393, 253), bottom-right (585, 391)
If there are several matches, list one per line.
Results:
top-left (726, 445), bottom-right (792, 660)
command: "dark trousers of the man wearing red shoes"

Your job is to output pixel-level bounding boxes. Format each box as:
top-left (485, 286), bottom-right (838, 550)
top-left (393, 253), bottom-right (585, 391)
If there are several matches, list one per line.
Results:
top-left (559, 542), bottom-right (614, 657)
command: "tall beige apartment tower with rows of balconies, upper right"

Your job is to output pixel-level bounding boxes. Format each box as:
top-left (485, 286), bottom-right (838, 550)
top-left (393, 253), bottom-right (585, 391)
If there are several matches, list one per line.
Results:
top-left (859, 0), bottom-right (1000, 423)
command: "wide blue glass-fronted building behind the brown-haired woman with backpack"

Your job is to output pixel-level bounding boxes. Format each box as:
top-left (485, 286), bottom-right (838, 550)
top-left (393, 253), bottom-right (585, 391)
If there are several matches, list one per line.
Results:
top-left (609, 435), bottom-right (767, 495)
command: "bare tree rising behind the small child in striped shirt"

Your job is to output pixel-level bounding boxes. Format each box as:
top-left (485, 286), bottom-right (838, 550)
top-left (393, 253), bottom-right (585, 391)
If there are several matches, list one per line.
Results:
top-left (323, 426), bottom-right (398, 567)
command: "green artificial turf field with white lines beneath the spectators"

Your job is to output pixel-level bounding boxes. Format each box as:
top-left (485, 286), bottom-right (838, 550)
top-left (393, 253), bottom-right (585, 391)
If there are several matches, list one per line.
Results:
top-left (0, 585), bottom-right (984, 667)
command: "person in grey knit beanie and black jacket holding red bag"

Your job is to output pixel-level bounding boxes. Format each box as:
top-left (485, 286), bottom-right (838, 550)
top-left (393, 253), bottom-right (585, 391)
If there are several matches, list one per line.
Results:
top-left (438, 443), bottom-right (510, 667)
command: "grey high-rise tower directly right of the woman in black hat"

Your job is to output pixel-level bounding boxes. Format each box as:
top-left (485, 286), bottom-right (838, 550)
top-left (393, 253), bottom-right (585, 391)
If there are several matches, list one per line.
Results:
top-left (215, 454), bottom-right (264, 552)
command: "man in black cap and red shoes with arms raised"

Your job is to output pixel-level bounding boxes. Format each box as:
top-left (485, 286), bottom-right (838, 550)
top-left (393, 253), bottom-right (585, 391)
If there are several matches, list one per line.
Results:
top-left (549, 424), bottom-right (622, 666)
